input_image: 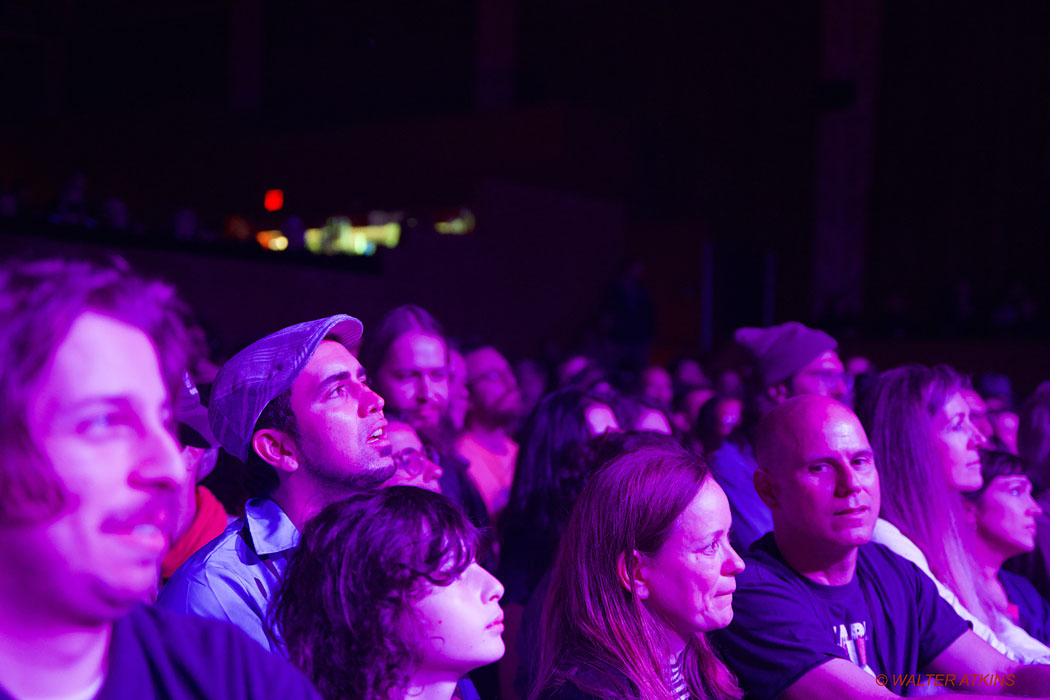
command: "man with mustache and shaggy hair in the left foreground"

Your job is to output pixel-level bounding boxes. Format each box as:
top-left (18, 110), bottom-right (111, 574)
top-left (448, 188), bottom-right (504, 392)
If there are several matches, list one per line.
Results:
top-left (0, 259), bottom-right (317, 700)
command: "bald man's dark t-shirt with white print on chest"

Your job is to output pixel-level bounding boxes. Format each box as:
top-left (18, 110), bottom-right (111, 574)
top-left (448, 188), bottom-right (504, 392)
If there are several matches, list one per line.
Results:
top-left (709, 533), bottom-right (969, 698)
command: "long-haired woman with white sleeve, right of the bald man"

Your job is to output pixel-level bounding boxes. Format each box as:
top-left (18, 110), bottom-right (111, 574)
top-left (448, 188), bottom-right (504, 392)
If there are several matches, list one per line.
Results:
top-left (858, 364), bottom-right (1050, 663)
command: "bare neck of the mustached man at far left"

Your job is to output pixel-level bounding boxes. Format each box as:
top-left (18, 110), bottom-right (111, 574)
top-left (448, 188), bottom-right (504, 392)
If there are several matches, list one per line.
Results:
top-left (0, 596), bottom-right (112, 698)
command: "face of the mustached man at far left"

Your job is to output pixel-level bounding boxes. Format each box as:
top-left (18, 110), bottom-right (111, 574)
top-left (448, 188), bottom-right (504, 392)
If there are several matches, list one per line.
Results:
top-left (13, 312), bottom-right (187, 622)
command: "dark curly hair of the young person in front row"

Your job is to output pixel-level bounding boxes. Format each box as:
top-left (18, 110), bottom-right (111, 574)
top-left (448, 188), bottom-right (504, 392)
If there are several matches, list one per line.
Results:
top-left (270, 486), bottom-right (479, 700)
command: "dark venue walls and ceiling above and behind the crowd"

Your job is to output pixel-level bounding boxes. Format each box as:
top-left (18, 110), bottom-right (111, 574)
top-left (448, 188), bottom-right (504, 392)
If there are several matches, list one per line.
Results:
top-left (0, 0), bottom-right (1050, 384)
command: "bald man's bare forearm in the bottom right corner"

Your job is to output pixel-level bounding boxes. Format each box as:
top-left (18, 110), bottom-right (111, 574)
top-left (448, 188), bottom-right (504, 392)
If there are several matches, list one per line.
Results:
top-left (926, 632), bottom-right (1050, 698)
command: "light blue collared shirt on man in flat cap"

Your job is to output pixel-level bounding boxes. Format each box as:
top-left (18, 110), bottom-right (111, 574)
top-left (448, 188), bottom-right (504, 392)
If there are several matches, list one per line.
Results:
top-left (156, 499), bottom-right (299, 655)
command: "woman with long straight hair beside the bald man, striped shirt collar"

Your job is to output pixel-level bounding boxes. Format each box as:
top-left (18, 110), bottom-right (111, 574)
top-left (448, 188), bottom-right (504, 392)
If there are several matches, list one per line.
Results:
top-left (532, 447), bottom-right (743, 700)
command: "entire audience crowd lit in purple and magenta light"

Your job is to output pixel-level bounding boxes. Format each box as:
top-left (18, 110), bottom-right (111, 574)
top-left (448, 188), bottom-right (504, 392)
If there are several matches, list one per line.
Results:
top-left (0, 252), bottom-right (1050, 700)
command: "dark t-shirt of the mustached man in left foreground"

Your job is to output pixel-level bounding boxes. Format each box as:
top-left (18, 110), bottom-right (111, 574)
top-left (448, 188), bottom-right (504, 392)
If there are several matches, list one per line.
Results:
top-left (0, 606), bottom-right (319, 700)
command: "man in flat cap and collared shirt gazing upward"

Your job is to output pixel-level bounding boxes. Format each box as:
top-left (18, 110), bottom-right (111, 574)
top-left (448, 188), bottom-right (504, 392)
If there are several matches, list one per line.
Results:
top-left (158, 315), bottom-right (395, 651)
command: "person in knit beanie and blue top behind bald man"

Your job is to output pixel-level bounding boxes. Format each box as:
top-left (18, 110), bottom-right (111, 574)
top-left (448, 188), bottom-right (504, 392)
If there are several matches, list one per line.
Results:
top-left (710, 321), bottom-right (848, 551)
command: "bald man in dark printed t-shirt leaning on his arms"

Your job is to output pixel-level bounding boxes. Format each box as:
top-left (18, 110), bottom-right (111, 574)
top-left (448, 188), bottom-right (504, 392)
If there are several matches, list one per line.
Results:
top-left (710, 396), bottom-right (1050, 700)
